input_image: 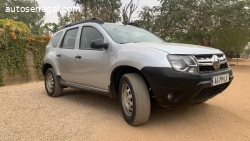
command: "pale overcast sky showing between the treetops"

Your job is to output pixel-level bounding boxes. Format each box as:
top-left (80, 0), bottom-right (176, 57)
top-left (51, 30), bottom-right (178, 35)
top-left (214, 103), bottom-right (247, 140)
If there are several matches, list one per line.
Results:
top-left (37, 0), bottom-right (159, 23)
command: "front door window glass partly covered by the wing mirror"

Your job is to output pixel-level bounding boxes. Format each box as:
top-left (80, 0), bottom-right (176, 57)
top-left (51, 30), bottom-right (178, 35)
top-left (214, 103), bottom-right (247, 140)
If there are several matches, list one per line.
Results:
top-left (80, 27), bottom-right (104, 49)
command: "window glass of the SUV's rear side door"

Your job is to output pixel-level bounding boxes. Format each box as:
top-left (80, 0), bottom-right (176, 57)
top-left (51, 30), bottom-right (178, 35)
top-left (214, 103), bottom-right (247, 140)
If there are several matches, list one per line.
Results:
top-left (61, 28), bottom-right (79, 49)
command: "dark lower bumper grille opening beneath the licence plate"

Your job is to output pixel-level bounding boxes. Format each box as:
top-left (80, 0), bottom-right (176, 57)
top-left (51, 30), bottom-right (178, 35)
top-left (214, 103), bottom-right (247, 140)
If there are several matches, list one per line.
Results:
top-left (194, 83), bottom-right (230, 100)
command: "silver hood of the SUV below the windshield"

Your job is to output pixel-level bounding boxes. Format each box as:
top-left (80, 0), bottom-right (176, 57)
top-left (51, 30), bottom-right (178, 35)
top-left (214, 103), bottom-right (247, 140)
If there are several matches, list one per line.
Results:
top-left (126, 43), bottom-right (223, 55)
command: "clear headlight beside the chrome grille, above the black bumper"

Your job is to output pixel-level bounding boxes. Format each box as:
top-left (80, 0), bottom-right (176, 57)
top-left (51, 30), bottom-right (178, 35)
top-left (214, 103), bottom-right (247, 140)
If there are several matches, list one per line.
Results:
top-left (167, 55), bottom-right (198, 73)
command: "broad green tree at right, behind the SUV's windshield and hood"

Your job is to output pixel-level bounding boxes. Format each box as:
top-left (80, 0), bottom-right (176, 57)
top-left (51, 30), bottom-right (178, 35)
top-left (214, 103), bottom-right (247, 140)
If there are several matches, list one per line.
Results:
top-left (140, 0), bottom-right (250, 46)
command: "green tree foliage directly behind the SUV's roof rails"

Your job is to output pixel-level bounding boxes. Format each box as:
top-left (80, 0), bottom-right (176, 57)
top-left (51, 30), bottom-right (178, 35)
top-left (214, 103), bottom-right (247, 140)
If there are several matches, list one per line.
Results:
top-left (42, 0), bottom-right (131, 34)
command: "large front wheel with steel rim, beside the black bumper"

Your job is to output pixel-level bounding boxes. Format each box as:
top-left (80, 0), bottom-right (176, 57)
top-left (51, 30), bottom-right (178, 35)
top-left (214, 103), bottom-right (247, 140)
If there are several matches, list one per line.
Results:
top-left (119, 73), bottom-right (151, 126)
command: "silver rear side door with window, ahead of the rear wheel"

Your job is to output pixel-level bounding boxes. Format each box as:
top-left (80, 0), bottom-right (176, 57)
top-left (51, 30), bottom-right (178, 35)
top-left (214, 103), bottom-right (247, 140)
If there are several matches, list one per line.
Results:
top-left (56, 27), bottom-right (79, 82)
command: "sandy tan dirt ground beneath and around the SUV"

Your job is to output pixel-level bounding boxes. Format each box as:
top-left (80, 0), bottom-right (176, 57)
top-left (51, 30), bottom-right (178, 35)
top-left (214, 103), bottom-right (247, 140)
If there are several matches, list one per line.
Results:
top-left (0, 59), bottom-right (250, 141)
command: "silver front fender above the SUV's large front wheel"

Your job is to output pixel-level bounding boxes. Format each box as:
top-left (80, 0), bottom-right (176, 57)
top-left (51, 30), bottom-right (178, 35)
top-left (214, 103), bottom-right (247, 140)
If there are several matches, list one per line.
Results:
top-left (110, 44), bottom-right (171, 74)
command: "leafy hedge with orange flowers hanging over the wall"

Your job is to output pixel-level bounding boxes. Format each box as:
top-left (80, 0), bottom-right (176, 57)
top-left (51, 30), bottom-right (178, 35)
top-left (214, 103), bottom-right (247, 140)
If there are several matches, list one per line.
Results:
top-left (0, 18), bottom-right (50, 86)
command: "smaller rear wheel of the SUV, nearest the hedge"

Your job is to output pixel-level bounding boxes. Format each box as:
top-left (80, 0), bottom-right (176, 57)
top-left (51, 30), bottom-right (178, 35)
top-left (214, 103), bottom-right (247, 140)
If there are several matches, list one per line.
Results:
top-left (44, 68), bottom-right (63, 97)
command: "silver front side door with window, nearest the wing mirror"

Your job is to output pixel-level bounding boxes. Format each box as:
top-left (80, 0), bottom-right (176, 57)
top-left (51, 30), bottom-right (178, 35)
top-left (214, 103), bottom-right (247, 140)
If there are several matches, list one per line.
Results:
top-left (75, 26), bottom-right (111, 90)
